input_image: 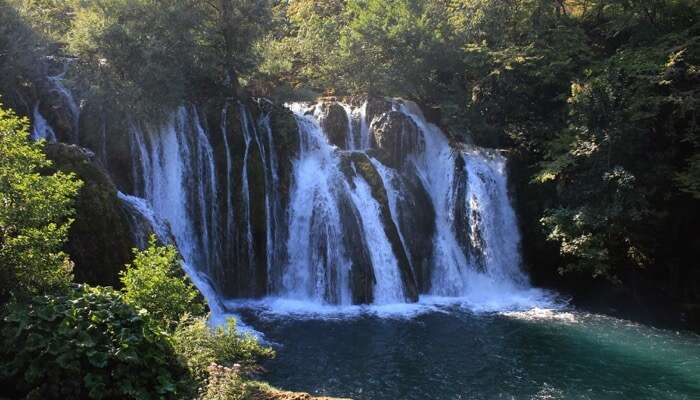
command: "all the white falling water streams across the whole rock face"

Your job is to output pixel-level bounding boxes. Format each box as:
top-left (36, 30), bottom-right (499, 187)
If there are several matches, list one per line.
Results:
top-left (23, 90), bottom-right (549, 324)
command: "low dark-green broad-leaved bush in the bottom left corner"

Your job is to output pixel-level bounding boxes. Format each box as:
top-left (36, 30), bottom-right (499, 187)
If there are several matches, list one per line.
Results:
top-left (0, 286), bottom-right (188, 399)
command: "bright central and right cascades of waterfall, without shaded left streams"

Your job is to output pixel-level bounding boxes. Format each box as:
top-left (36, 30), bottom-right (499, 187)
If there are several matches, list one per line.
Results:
top-left (279, 101), bottom-right (527, 304)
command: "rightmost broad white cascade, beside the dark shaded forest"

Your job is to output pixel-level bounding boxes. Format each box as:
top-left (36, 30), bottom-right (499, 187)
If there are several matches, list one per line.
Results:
top-left (400, 103), bottom-right (528, 297)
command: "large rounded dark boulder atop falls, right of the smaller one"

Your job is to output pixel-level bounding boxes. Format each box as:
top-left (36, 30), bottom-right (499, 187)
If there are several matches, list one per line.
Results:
top-left (370, 111), bottom-right (425, 168)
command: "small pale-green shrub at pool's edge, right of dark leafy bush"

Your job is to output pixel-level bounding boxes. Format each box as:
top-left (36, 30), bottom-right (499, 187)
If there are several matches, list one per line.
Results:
top-left (173, 318), bottom-right (274, 382)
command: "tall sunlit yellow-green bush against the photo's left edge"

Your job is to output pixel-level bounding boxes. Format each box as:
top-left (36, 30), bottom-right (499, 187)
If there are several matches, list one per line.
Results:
top-left (0, 107), bottom-right (81, 300)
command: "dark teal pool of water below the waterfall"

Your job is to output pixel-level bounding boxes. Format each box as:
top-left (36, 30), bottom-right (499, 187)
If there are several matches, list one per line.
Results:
top-left (234, 304), bottom-right (700, 400)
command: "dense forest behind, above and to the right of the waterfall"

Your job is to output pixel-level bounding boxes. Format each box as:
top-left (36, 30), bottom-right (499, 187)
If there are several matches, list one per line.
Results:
top-left (0, 0), bottom-right (700, 302)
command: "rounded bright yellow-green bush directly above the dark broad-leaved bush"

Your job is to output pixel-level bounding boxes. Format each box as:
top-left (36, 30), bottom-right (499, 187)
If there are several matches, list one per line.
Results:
top-left (121, 236), bottom-right (204, 329)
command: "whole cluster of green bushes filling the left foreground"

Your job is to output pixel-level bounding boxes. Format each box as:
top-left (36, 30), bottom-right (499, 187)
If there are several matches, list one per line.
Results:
top-left (0, 104), bottom-right (282, 399)
